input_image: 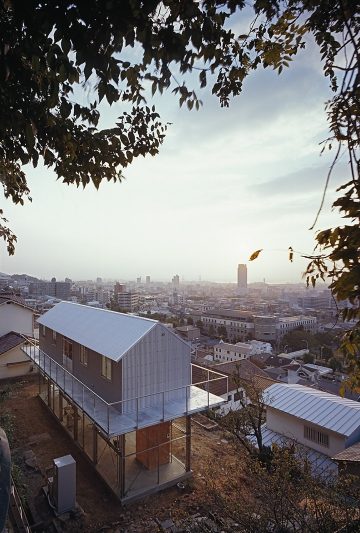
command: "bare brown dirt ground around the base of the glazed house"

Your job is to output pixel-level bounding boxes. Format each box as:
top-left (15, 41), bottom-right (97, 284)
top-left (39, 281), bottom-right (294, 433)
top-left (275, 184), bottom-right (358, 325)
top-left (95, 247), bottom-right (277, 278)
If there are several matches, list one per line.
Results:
top-left (0, 376), bottom-right (242, 533)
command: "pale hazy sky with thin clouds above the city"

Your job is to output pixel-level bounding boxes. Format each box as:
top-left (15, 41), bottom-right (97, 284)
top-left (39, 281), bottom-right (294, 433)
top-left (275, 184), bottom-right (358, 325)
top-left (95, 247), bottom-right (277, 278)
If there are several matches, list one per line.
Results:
top-left (0, 32), bottom-right (346, 282)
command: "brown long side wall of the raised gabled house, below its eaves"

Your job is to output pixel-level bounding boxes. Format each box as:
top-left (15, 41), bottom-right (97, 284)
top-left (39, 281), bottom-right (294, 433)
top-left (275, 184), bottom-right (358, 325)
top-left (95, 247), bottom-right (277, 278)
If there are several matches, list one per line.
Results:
top-left (39, 326), bottom-right (122, 403)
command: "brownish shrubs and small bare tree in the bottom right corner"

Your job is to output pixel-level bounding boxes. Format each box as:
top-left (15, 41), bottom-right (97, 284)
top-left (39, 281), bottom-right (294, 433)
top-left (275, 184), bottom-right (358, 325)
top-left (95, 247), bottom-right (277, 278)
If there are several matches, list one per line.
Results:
top-left (211, 374), bottom-right (360, 533)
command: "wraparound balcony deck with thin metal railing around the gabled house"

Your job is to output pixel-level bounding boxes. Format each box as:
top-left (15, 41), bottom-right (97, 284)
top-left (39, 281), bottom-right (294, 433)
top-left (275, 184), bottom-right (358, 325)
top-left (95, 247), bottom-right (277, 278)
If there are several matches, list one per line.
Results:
top-left (23, 341), bottom-right (228, 437)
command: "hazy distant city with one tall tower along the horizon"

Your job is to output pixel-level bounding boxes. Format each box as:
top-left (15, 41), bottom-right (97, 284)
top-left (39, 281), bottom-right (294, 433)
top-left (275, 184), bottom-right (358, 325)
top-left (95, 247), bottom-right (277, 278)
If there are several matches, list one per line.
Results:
top-left (0, 264), bottom-right (346, 349)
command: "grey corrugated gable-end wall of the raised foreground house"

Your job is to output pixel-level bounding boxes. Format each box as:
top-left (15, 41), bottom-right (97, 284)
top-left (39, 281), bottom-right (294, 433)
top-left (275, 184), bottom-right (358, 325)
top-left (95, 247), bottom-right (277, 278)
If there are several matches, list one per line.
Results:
top-left (123, 324), bottom-right (191, 408)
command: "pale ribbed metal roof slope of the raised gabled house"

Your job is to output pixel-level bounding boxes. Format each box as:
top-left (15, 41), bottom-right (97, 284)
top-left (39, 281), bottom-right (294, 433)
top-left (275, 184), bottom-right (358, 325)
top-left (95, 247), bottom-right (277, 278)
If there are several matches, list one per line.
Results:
top-left (38, 302), bottom-right (158, 361)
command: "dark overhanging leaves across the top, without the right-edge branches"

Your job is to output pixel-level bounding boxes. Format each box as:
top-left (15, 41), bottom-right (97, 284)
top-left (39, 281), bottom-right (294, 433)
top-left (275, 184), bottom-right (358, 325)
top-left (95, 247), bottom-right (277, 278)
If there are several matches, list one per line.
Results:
top-left (0, 0), bottom-right (348, 249)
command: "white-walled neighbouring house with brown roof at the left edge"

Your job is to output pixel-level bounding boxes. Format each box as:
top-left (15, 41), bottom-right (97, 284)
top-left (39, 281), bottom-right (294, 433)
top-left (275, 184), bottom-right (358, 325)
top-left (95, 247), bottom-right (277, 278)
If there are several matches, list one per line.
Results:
top-left (0, 293), bottom-right (34, 379)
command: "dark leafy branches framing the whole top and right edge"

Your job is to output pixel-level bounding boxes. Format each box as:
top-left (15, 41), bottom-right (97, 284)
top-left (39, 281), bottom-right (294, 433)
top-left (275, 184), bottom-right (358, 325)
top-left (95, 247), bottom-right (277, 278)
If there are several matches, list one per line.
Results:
top-left (0, 0), bottom-right (360, 372)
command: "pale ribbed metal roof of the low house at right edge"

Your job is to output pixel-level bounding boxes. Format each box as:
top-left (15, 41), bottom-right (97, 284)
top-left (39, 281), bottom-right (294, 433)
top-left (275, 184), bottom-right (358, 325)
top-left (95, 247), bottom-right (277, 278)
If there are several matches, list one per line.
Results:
top-left (264, 383), bottom-right (360, 437)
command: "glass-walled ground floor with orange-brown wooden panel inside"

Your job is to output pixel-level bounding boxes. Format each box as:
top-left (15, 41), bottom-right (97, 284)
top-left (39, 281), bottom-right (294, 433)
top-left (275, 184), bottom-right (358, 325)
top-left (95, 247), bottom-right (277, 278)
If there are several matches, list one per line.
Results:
top-left (39, 373), bottom-right (191, 501)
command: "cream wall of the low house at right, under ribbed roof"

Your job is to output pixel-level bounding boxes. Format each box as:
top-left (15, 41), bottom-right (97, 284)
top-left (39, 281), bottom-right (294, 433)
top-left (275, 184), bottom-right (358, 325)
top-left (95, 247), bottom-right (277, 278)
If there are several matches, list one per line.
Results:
top-left (266, 407), bottom-right (345, 457)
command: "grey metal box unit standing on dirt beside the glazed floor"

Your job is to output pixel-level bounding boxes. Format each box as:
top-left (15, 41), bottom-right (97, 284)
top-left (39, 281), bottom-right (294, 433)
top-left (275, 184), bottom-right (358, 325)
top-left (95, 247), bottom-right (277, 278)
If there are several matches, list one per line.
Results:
top-left (51, 455), bottom-right (76, 515)
